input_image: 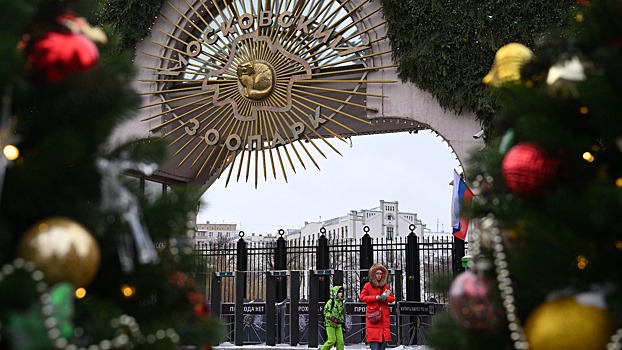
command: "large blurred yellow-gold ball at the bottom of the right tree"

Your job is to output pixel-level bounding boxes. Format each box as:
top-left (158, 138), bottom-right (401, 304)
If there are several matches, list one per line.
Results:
top-left (525, 293), bottom-right (616, 350)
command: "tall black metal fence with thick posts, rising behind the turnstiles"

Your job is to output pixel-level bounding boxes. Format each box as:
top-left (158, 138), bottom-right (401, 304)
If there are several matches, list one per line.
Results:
top-left (195, 234), bottom-right (466, 303)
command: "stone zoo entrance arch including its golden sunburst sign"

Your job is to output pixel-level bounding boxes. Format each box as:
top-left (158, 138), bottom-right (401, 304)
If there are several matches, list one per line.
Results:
top-left (117, 0), bottom-right (483, 188)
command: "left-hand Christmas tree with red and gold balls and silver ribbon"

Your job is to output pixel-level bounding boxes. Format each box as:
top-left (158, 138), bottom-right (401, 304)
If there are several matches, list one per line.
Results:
top-left (0, 0), bottom-right (221, 349)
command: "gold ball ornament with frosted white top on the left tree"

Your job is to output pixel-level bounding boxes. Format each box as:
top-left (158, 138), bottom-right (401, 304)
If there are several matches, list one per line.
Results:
top-left (18, 217), bottom-right (100, 287)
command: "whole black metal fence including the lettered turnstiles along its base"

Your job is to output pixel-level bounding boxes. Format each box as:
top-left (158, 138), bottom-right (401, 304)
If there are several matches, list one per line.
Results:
top-left (195, 231), bottom-right (466, 347)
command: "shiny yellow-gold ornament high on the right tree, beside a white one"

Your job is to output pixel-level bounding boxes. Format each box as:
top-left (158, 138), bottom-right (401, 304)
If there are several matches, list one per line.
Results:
top-left (482, 43), bottom-right (533, 87)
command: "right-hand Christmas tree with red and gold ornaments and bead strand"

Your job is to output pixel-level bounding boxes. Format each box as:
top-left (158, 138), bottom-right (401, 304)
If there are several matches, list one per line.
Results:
top-left (431, 0), bottom-right (622, 350)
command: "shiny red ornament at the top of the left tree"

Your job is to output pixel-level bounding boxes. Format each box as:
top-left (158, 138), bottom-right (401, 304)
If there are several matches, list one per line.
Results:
top-left (28, 32), bottom-right (99, 82)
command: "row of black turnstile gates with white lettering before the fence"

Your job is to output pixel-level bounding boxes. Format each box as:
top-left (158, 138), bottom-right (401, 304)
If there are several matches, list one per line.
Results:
top-left (210, 269), bottom-right (443, 347)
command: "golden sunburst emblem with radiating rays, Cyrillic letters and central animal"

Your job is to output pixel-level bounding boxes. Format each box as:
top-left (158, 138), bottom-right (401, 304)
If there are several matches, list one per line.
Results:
top-left (143, 0), bottom-right (394, 187)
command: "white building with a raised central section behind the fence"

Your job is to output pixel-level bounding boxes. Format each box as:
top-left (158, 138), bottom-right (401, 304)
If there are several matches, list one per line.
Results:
top-left (286, 200), bottom-right (425, 240)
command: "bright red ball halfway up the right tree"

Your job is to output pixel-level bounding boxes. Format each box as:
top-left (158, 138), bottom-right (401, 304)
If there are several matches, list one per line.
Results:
top-left (501, 143), bottom-right (561, 197)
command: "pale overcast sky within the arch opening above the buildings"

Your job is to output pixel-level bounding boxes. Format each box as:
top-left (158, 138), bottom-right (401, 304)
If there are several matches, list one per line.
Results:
top-left (197, 131), bottom-right (461, 234)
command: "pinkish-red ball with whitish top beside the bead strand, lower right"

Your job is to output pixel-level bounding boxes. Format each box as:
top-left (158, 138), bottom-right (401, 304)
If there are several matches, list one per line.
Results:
top-left (449, 271), bottom-right (501, 331)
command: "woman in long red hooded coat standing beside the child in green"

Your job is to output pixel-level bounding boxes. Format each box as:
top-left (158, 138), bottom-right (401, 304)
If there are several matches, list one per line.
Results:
top-left (360, 264), bottom-right (395, 350)
